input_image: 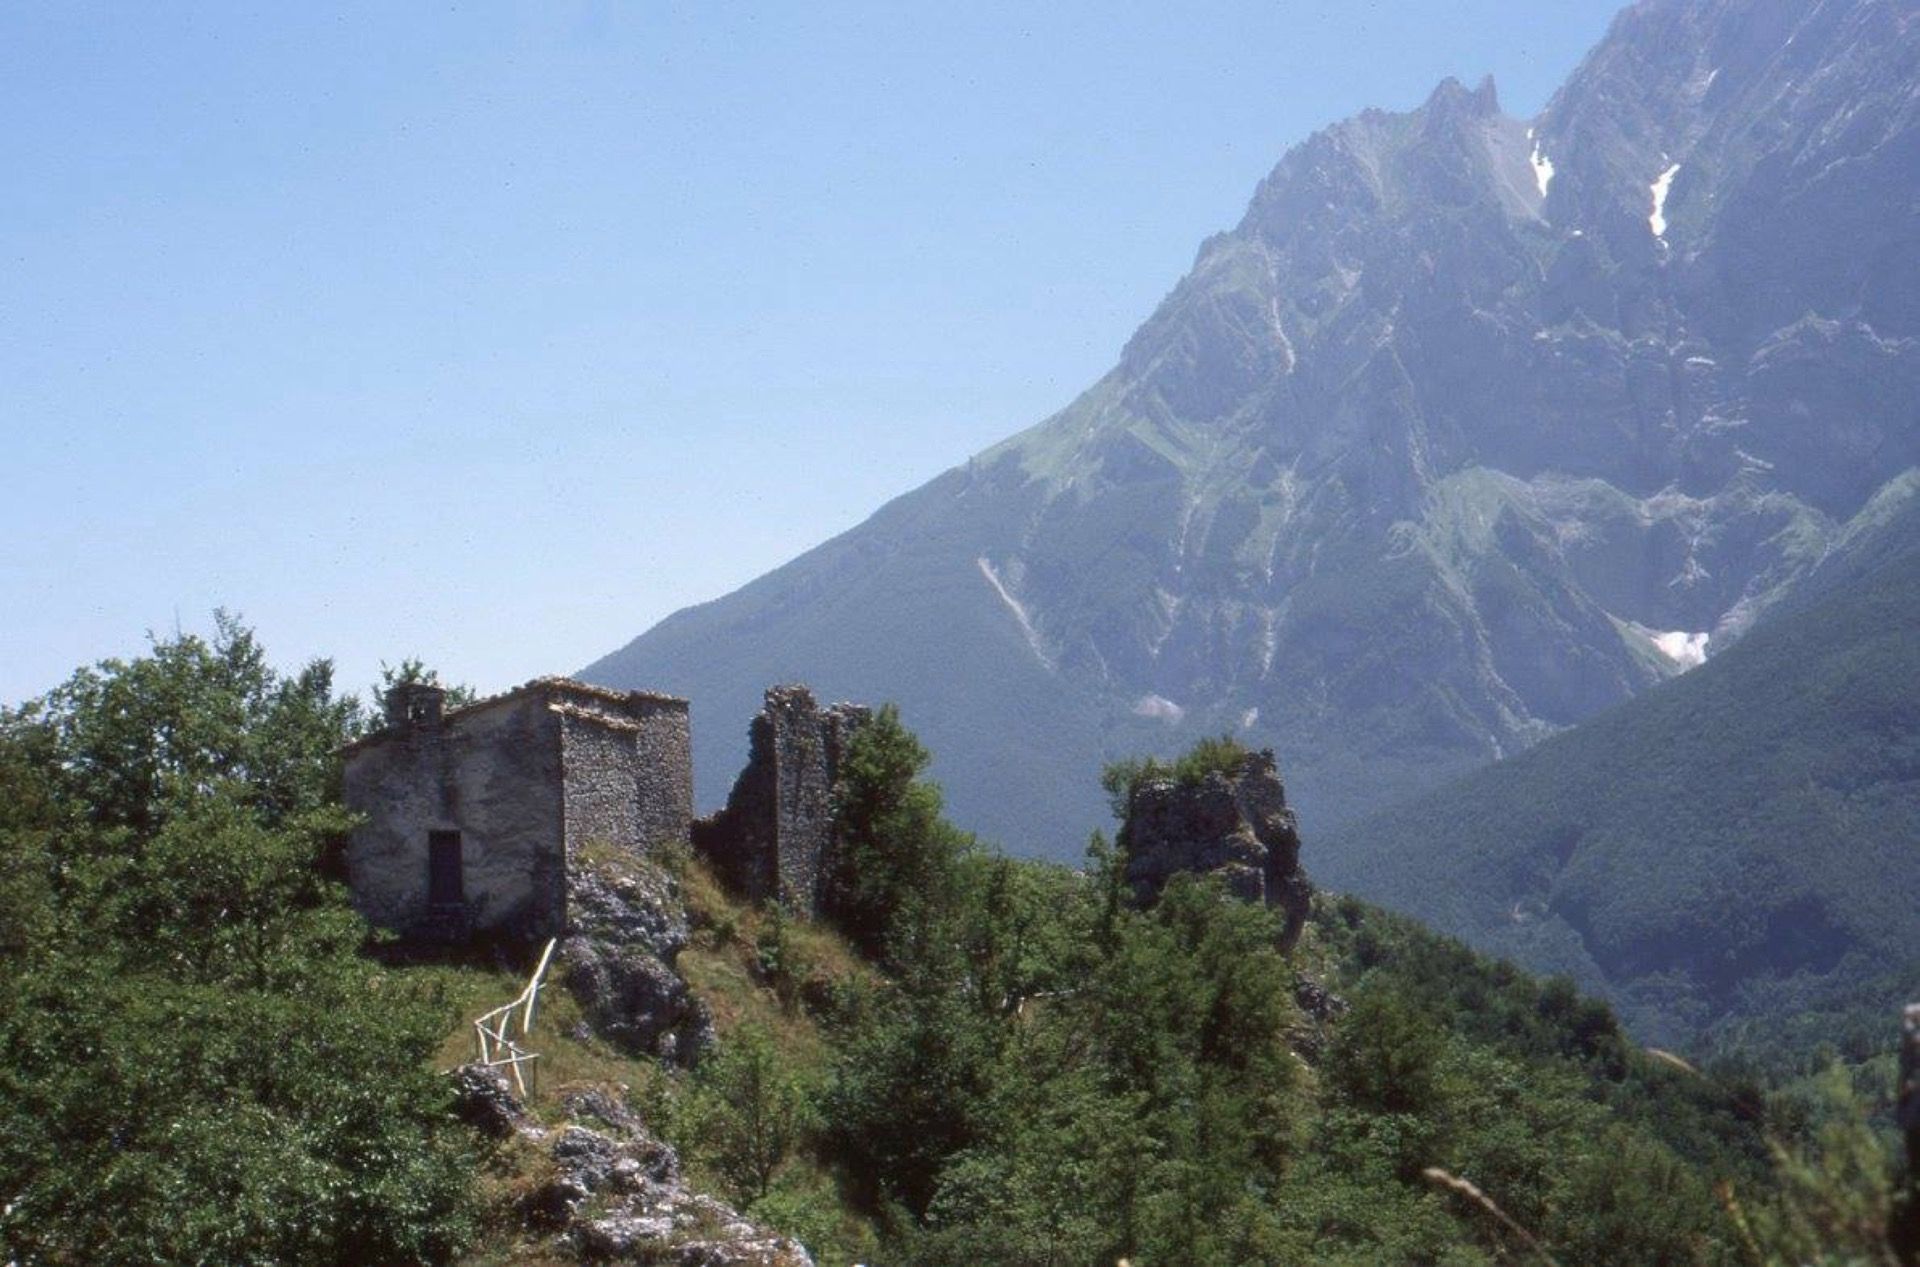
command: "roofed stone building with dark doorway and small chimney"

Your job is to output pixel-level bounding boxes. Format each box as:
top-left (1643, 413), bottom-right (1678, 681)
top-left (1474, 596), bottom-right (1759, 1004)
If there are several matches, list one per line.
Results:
top-left (344, 678), bottom-right (693, 941)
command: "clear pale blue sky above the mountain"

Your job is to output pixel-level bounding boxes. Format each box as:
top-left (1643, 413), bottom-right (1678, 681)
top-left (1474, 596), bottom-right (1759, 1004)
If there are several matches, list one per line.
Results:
top-left (0, 0), bottom-right (1615, 701)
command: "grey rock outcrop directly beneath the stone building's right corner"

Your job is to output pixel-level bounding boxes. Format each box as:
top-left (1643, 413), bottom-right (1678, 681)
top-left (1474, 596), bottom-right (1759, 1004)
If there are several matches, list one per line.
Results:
top-left (561, 856), bottom-right (712, 1064)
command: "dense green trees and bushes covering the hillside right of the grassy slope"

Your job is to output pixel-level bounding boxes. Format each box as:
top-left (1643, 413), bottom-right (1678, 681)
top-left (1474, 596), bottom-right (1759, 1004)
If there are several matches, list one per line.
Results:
top-left (685, 716), bottom-right (1887, 1267)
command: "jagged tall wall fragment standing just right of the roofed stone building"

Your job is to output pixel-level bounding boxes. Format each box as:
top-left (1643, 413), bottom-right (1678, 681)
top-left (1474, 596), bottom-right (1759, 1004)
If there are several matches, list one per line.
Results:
top-left (693, 685), bottom-right (870, 914)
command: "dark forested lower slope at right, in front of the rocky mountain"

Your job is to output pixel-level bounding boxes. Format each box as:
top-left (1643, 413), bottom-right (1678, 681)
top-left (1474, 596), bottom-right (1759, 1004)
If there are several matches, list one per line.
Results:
top-left (1315, 518), bottom-right (1920, 1044)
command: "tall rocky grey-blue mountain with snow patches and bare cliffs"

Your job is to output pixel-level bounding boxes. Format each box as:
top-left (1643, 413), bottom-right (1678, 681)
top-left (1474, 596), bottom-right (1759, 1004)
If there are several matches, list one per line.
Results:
top-left (586, 0), bottom-right (1920, 854)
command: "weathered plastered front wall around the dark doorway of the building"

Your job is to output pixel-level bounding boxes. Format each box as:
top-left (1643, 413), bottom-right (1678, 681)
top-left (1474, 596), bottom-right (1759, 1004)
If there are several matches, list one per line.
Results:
top-left (344, 697), bottom-right (566, 941)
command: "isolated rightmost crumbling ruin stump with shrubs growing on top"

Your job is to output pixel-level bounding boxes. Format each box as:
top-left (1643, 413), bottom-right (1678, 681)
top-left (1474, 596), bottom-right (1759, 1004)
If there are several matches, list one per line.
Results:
top-left (1121, 751), bottom-right (1313, 946)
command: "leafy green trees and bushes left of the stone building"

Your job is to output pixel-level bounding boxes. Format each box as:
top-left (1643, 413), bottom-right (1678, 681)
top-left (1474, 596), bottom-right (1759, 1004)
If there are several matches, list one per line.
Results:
top-left (0, 616), bottom-right (470, 1263)
